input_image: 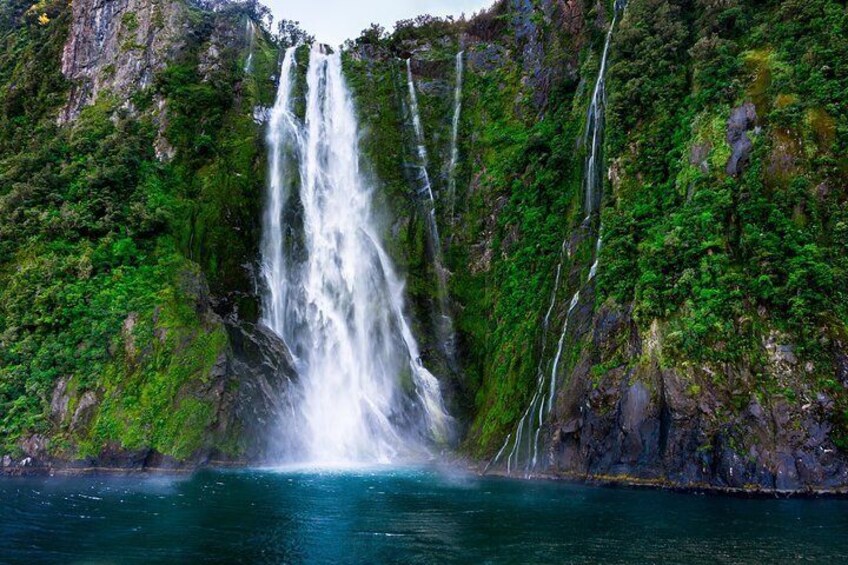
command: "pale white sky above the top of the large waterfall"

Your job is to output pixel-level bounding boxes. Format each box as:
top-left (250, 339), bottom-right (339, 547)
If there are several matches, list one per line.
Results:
top-left (263, 0), bottom-right (494, 46)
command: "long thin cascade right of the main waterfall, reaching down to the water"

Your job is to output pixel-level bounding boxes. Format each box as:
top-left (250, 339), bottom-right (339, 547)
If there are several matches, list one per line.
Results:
top-left (487, 0), bottom-right (625, 475)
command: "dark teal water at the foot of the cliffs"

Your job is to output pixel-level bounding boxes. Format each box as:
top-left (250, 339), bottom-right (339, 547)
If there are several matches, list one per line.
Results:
top-left (0, 464), bottom-right (848, 563)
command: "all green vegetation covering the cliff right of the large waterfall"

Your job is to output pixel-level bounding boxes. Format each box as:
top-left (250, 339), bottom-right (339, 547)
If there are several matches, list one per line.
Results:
top-left (350, 0), bottom-right (848, 451)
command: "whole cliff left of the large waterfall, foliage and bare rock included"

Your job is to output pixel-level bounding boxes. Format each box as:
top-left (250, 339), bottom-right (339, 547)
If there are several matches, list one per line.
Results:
top-left (0, 0), bottom-right (286, 473)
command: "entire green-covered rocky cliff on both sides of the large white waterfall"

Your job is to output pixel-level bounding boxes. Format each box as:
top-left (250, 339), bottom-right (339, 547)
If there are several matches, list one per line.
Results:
top-left (0, 0), bottom-right (848, 490)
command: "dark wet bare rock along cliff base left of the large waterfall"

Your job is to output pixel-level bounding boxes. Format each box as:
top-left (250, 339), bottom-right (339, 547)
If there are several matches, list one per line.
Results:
top-left (0, 318), bottom-right (296, 475)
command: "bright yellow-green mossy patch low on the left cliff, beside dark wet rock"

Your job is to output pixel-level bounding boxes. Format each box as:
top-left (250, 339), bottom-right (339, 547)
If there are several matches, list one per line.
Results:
top-left (80, 264), bottom-right (227, 459)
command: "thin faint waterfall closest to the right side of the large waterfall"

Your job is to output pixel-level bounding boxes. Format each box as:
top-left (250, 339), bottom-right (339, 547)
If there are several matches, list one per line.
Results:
top-left (406, 58), bottom-right (458, 369)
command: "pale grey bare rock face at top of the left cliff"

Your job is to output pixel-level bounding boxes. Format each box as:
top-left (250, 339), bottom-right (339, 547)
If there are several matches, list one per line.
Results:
top-left (60, 0), bottom-right (185, 122)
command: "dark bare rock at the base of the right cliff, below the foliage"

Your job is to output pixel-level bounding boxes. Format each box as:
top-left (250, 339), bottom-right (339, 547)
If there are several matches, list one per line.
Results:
top-left (551, 302), bottom-right (848, 491)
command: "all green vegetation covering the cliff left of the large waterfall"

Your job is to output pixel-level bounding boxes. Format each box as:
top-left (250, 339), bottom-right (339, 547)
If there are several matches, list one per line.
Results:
top-left (0, 2), bottom-right (277, 458)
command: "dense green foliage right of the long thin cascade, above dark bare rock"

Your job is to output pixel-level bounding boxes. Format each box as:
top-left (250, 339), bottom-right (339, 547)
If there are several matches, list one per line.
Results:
top-left (599, 0), bottom-right (848, 440)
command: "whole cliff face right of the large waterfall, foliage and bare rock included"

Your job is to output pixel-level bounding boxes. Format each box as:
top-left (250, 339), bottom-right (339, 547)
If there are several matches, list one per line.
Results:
top-left (348, 0), bottom-right (848, 490)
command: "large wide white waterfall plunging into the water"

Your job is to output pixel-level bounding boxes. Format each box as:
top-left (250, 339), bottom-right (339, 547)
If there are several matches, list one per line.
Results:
top-left (262, 46), bottom-right (451, 464)
